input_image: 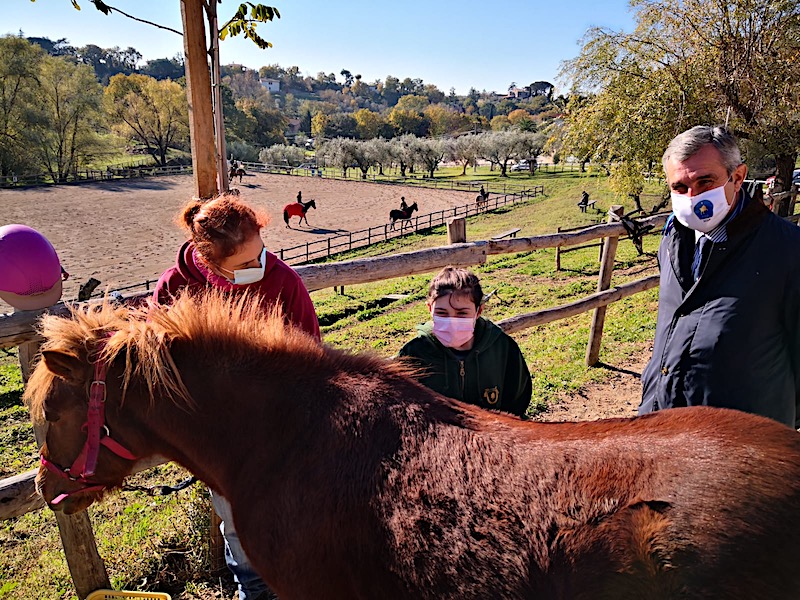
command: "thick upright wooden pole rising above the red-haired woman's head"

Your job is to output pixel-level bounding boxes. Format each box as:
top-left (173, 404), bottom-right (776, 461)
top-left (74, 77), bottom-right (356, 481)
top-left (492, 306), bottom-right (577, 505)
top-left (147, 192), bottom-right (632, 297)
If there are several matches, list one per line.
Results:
top-left (181, 0), bottom-right (219, 198)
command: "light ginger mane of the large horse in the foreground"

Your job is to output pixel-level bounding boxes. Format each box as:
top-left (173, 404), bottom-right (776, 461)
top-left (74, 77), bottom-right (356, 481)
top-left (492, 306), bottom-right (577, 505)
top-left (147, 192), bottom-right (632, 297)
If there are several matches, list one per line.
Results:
top-left (25, 290), bottom-right (410, 414)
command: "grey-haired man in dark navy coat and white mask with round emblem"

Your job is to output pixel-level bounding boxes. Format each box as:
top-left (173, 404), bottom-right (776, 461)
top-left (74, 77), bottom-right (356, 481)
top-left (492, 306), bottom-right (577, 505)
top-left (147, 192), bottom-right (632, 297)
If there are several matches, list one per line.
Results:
top-left (639, 126), bottom-right (800, 427)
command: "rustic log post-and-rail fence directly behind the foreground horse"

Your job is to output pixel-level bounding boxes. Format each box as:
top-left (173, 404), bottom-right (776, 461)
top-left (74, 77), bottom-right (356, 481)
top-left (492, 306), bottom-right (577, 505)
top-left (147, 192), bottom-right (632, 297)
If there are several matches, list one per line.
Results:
top-left (0, 207), bottom-right (667, 598)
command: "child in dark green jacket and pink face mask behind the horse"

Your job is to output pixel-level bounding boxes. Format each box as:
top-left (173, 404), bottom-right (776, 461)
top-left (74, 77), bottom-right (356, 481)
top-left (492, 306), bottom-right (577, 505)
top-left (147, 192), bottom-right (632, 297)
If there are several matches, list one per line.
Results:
top-left (398, 267), bottom-right (531, 416)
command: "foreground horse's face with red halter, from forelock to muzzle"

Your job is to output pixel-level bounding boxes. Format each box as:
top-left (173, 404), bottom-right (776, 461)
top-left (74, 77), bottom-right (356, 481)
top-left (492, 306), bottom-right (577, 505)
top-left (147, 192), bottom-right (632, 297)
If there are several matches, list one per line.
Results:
top-left (25, 304), bottom-right (145, 514)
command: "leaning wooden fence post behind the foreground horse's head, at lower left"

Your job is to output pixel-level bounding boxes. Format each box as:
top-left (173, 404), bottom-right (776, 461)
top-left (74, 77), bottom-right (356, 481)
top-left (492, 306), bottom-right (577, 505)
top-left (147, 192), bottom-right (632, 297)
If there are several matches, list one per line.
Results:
top-left (19, 342), bottom-right (111, 598)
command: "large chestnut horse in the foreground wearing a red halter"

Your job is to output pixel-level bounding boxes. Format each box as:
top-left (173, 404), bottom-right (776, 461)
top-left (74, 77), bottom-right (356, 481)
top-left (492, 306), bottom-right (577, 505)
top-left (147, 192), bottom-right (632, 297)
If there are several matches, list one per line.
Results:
top-left (26, 296), bottom-right (800, 600)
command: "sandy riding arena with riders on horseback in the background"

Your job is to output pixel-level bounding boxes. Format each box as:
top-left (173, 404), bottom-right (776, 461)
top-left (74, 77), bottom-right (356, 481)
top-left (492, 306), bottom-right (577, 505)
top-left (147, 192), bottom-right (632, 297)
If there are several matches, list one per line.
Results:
top-left (0, 174), bottom-right (475, 308)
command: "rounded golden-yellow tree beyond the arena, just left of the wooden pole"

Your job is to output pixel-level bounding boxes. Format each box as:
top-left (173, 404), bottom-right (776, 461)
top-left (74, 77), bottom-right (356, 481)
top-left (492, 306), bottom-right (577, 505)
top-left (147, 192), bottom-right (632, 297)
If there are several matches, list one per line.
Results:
top-left (105, 75), bottom-right (189, 165)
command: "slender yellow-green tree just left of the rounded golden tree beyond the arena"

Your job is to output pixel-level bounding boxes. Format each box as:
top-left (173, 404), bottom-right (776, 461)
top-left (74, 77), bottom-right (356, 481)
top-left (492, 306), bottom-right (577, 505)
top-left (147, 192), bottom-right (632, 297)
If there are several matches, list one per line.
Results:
top-left (28, 57), bottom-right (103, 182)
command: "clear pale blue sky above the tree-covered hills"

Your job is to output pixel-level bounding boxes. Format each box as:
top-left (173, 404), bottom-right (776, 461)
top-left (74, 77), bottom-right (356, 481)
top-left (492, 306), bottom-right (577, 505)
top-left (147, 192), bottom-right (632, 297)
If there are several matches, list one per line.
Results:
top-left (6, 0), bottom-right (633, 94)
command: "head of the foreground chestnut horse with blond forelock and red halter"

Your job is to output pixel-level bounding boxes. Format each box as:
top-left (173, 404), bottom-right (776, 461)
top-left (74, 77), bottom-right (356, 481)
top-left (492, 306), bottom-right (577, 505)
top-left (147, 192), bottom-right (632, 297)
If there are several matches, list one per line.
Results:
top-left (25, 303), bottom-right (191, 514)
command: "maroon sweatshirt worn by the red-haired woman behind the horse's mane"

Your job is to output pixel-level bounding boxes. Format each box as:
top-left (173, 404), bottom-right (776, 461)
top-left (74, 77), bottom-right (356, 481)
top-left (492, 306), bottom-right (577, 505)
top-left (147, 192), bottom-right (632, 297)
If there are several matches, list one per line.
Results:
top-left (153, 242), bottom-right (321, 340)
